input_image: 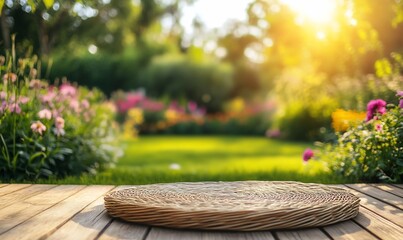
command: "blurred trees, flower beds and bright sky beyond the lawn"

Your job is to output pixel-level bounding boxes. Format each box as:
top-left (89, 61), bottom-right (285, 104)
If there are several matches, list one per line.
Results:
top-left (0, 0), bottom-right (403, 141)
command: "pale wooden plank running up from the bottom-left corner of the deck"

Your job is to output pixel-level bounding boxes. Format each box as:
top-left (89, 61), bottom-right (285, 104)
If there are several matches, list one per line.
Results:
top-left (0, 186), bottom-right (111, 240)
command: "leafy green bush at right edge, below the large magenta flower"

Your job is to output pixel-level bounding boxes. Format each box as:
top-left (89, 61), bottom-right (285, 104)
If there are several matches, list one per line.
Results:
top-left (318, 99), bottom-right (403, 183)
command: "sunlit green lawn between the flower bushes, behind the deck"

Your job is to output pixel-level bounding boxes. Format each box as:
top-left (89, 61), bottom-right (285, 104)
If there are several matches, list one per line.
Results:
top-left (35, 136), bottom-right (343, 185)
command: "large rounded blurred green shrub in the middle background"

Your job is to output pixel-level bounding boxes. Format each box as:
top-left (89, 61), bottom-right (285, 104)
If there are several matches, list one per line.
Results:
top-left (139, 55), bottom-right (233, 112)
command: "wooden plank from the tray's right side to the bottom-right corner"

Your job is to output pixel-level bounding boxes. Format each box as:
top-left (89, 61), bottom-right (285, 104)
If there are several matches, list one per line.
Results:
top-left (353, 208), bottom-right (403, 240)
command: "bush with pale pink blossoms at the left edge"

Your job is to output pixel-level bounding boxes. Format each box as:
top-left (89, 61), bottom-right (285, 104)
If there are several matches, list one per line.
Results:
top-left (0, 54), bottom-right (121, 182)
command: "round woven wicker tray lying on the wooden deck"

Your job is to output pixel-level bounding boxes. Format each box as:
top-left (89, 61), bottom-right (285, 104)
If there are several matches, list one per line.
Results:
top-left (105, 181), bottom-right (360, 231)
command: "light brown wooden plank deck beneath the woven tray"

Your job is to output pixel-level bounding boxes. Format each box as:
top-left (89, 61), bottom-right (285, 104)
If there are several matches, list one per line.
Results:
top-left (0, 184), bottom-right (403, 240)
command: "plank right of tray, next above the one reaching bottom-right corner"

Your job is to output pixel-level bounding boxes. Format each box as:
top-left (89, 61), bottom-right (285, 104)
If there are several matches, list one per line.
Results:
top-left (347, 185), bottom-right (403, 227)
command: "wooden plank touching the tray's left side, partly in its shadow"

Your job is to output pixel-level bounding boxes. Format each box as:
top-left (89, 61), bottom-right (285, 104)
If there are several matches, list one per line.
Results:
top-left (47, 186), bottom-right (113, 240)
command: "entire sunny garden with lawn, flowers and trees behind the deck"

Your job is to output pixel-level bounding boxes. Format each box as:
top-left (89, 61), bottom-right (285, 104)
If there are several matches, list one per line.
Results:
top-left (0, 0), bottom-right (403, 184)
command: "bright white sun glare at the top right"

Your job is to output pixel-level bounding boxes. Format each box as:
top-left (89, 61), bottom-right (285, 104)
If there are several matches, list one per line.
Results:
top-left (282, 0), bottom-right (337, 24)
